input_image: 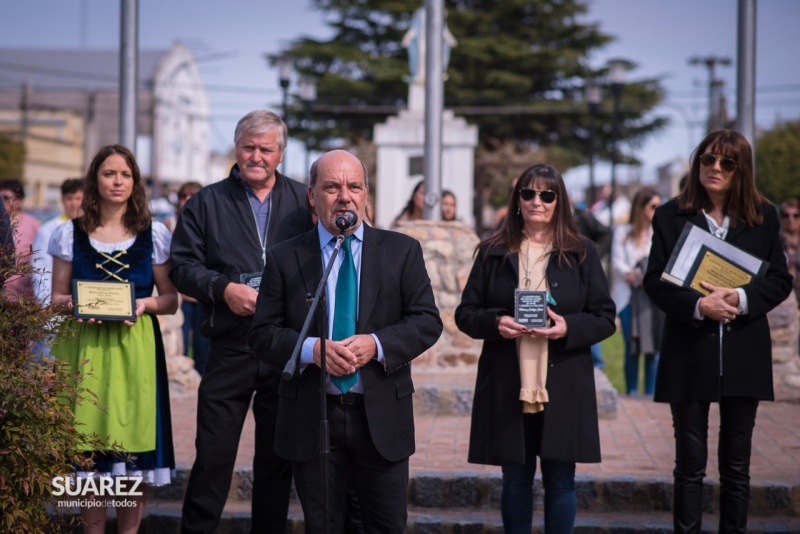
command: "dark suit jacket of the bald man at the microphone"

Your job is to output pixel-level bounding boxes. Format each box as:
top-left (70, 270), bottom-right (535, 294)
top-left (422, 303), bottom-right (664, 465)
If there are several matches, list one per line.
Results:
top-left (248, 226), bottom-right (442, 462)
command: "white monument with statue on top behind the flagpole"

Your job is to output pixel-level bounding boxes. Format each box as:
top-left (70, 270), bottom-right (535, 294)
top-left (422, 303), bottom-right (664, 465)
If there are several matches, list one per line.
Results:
top-left (373, 8), bottom-right (478, 228)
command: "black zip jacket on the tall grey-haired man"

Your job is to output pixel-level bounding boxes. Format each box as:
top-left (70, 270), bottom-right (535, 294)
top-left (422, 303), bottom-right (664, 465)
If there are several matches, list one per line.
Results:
top-left (169, 165), bottom-right (313, 350)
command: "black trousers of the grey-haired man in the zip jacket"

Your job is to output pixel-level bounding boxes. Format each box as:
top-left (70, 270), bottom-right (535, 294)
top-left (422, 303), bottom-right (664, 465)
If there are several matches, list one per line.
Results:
top-left (181, 344), bottom-right (292, 534)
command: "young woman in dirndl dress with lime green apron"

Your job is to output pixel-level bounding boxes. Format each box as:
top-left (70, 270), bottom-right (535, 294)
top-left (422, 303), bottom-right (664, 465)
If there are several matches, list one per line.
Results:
top-left (48, 145), bottom-right (178, 534)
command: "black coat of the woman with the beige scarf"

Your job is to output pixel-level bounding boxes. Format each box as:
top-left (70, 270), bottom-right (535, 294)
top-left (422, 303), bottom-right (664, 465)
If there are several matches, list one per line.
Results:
top-left (456, 240), bottom-right (616, 465)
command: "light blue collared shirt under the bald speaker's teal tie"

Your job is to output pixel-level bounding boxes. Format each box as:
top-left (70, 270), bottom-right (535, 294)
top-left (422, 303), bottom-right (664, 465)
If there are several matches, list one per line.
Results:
top-left (300, 224), bottom-right (384, 394)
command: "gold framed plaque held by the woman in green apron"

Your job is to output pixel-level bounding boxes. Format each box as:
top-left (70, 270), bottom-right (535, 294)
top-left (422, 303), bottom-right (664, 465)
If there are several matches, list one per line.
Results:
top-left (72, 280), bottom-right (136, 321)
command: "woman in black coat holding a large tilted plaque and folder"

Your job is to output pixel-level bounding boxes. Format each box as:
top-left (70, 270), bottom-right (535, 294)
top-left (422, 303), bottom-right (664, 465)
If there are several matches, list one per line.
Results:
top-left (644, 130), bottom-right (792, 532)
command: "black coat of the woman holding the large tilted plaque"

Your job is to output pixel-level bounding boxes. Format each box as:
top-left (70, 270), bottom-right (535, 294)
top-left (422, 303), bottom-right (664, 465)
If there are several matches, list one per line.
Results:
top-left (644, 200), bottom-right (792, 402)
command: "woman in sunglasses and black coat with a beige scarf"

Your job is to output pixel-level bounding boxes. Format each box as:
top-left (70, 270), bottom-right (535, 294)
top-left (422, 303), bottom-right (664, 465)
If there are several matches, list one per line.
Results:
top-left (456, 165), bottom-right (615, 534)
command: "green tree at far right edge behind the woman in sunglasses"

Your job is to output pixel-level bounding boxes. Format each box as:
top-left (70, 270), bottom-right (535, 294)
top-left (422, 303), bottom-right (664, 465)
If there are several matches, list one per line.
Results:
top-left (756, 120), bottom-right (800, 203)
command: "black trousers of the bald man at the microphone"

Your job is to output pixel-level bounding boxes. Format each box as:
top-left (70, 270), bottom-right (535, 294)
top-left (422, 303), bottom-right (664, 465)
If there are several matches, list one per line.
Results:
top-left (292, 402), bottom-right (408, 534)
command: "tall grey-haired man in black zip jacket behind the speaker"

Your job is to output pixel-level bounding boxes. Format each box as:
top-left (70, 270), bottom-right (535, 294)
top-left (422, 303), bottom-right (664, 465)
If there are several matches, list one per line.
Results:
top-left (170, 111), bottom-right (313, 533)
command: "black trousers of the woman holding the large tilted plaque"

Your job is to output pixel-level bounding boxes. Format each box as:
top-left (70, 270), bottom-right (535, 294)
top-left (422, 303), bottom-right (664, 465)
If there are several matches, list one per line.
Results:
top-left (670, 397), bottom-right (758, 534)
